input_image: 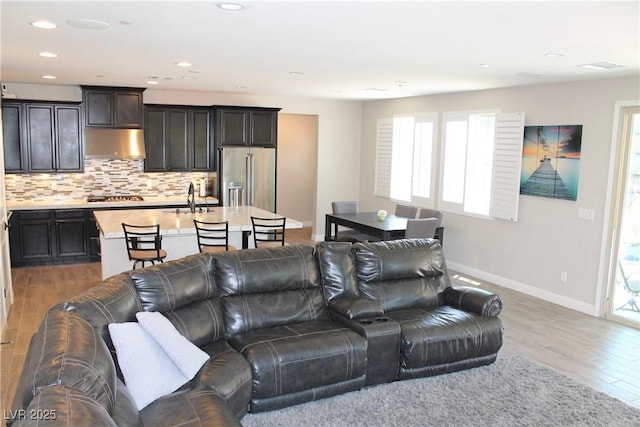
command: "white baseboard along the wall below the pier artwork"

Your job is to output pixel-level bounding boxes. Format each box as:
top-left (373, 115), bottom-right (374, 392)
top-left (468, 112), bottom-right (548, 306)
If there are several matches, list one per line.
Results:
top-left (447, 261), bottom-right (599, 317)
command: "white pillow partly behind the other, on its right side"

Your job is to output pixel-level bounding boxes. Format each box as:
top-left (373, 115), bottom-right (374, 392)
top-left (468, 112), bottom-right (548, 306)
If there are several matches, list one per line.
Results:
top-left (136, 311), bottom-right (209, 379)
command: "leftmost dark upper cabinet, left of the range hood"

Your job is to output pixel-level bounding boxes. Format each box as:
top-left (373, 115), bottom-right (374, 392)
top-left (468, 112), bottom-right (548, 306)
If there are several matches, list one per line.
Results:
top-left (2, 102), bottom-right (84, 173)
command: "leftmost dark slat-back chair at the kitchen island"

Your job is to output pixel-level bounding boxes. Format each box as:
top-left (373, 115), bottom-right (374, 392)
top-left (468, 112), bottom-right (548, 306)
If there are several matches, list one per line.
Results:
top-left (122, 222), bottom-right (167, 269)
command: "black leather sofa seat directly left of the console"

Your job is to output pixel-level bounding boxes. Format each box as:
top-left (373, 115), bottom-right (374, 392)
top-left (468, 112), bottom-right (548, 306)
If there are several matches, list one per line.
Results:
top-left (229, 320), bottom-right (367, 399)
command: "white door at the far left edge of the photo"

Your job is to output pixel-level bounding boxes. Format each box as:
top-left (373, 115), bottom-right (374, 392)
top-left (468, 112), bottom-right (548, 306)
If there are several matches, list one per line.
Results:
top-left (0, 103), bottom-right (13, 338)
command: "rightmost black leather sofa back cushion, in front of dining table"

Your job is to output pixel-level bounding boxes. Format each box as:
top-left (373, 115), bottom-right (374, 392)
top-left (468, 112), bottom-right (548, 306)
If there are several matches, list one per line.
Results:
top-left (351, 239), bottom-right (450, 312)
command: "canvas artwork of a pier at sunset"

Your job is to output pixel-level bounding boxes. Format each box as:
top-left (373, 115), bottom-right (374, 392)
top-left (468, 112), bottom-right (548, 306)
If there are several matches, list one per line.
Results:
top-left (520, 125), bottom-right (582, 200)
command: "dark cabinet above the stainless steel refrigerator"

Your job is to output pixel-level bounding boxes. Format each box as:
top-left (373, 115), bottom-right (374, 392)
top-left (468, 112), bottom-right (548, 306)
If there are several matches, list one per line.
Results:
top-left (215, 107), bottom-right (280, 147)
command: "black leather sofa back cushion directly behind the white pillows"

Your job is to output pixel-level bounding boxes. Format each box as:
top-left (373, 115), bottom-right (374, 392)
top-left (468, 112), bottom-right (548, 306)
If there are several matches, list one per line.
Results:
top-left (129, 253), bottom-right (224, 346)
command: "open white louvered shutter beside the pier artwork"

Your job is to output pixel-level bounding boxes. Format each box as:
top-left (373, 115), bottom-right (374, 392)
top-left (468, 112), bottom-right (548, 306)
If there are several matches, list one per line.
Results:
top-left (491, 113), bottom-right (524, 221)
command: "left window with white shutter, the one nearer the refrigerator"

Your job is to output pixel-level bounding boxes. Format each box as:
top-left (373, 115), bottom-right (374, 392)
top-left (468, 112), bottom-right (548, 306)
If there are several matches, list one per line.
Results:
top-left (375, 114), bottom-right (437, 207)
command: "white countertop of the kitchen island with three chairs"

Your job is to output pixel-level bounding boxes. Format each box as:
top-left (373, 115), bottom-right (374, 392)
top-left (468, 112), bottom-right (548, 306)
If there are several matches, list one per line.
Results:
top-left (92, 204), bottom-right (302, 239)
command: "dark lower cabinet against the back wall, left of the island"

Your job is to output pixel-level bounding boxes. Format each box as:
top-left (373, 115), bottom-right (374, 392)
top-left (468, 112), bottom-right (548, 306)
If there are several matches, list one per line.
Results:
top-left (9, 209), bottom-right (100, 267)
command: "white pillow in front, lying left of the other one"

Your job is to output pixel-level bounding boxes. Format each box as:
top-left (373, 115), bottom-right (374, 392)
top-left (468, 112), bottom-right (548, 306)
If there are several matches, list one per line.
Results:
top-left (109, 322), bottom-right (189, 410)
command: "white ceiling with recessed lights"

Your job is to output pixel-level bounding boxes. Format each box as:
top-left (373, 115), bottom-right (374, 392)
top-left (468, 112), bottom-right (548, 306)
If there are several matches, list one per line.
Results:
top-left (0, 0), bottom-right (640, 100)
